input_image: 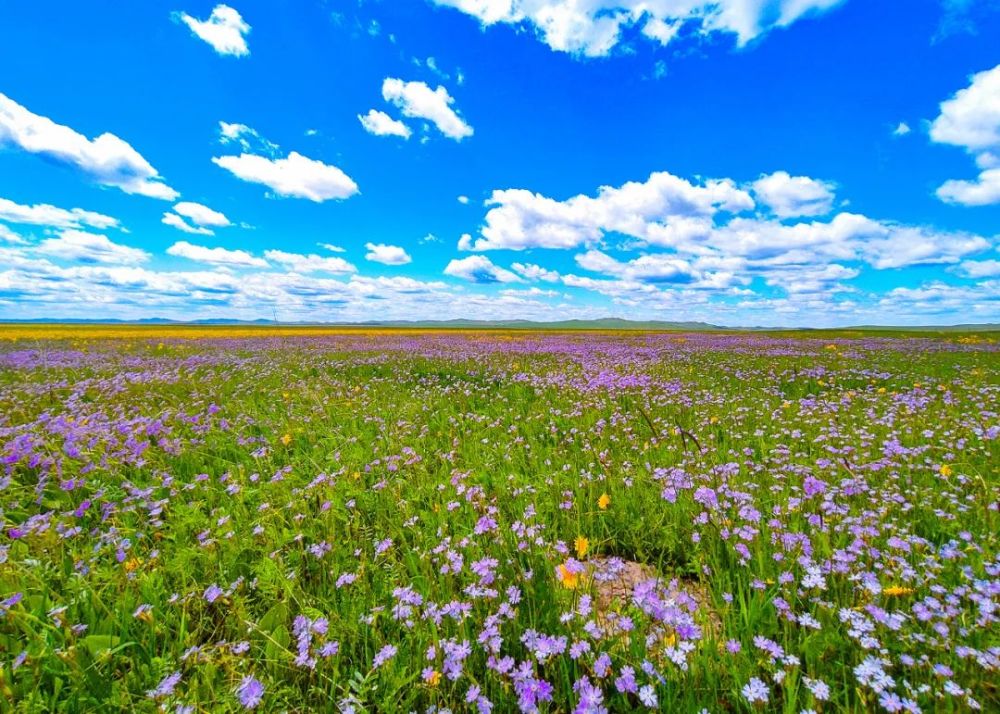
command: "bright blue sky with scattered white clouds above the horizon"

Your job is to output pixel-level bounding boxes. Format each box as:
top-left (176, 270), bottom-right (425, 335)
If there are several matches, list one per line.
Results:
top-left (0, 0), bottom-right (1000, 326)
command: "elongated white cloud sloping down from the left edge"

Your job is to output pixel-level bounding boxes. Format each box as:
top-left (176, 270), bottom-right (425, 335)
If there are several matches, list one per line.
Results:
top-left (0, 94), bottom-right (179, 201)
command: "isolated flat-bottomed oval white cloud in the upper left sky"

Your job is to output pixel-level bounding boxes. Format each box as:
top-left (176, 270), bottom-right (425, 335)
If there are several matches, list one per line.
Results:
top-left (212, 151), bottom-right (358, 203)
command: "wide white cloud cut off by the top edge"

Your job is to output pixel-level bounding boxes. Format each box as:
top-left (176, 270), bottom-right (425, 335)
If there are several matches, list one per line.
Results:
top-left (434, 0), bottom-right (842, 57)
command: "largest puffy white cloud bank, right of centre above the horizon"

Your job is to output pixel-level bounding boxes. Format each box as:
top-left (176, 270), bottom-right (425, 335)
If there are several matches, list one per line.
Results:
top-left (458, 172), bottom-right (991, 282)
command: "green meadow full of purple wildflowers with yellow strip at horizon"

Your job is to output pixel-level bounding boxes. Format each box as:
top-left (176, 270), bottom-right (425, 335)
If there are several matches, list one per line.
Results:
top-left (0, 326), bottom-right (1000, 714)
